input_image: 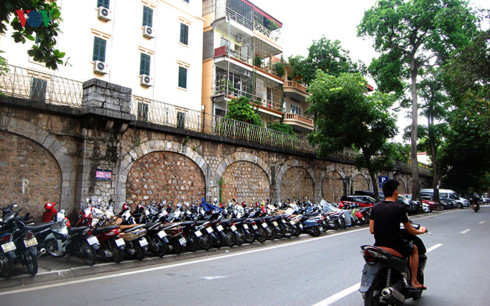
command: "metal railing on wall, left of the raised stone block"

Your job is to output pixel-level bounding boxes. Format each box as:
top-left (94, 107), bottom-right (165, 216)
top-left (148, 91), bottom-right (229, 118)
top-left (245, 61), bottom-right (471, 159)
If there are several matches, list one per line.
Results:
top-left (0, 65), bottom-right (83, 108)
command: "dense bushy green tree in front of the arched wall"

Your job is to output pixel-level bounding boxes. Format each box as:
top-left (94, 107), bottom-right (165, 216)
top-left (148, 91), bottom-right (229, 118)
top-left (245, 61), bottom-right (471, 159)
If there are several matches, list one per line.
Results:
top-left (307, 70), bottom-right (397, 201)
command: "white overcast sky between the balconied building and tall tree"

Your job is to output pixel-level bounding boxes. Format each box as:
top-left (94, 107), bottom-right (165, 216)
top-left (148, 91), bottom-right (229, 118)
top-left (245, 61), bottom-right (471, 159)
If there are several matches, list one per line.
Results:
top-left (251, 0), bottom-right (490, 142)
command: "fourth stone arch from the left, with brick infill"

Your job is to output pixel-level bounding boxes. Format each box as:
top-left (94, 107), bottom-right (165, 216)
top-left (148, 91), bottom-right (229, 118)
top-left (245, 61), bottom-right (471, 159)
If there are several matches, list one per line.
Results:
top-left (276, 159), bottom-right (317, 201)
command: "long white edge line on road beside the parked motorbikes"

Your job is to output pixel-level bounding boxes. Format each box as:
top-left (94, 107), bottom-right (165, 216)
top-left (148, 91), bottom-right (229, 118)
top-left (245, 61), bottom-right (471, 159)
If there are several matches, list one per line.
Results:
top-left (0, 228), bottom-right (369, 296)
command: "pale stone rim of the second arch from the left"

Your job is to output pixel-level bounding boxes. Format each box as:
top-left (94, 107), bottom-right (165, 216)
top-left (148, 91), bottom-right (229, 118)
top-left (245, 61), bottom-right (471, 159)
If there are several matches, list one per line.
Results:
top-left (120, 140), bottom-right (209, 203)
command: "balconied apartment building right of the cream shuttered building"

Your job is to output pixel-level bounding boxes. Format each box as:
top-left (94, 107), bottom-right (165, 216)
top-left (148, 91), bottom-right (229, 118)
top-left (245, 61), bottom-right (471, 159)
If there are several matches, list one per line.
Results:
top-left (202, 0), bottom-right (283, 122)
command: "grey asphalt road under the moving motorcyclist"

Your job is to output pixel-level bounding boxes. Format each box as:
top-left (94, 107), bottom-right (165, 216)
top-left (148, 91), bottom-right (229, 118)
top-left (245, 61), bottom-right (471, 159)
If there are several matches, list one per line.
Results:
top-left (0, 206), bottom-right (490, 305)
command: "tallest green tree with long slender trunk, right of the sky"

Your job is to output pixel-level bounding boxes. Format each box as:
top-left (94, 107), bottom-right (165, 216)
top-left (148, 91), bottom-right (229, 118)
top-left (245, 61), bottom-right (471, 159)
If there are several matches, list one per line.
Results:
top-left (358, 0), bottom-right (477, 198)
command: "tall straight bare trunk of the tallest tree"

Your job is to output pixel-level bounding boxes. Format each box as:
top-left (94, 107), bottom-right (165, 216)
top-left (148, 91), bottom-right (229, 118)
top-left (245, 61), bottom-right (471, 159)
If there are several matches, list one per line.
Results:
top-left (410, 53), bottom-right (421, 201)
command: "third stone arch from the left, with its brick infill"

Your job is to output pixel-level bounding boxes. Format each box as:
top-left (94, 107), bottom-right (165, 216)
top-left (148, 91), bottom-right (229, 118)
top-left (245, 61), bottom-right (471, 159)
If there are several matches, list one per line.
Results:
top-left (213, 152), bottom-right (272, 204)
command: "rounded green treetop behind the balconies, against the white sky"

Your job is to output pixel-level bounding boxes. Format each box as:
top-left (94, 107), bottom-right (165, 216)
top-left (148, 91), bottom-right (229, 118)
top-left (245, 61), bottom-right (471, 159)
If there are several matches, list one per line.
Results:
top-left (288, 36), bottom-right (358, 84)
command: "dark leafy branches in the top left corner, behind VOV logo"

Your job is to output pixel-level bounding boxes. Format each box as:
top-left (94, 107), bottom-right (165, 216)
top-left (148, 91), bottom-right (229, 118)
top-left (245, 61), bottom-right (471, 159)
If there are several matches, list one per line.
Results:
top-left (0, 0), bottom-right (65, 69)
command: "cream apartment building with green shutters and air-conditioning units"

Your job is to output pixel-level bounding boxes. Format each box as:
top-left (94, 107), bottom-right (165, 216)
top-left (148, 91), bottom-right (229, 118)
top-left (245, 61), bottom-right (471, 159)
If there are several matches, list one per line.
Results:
top-left (0, 0), bottom-right (204, 112)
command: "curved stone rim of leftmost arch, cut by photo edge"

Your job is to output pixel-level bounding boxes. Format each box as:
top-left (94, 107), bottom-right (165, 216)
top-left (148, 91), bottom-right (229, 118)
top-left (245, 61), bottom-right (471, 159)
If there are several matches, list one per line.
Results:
top-left (1, 117), bottom-right (76, 214)
